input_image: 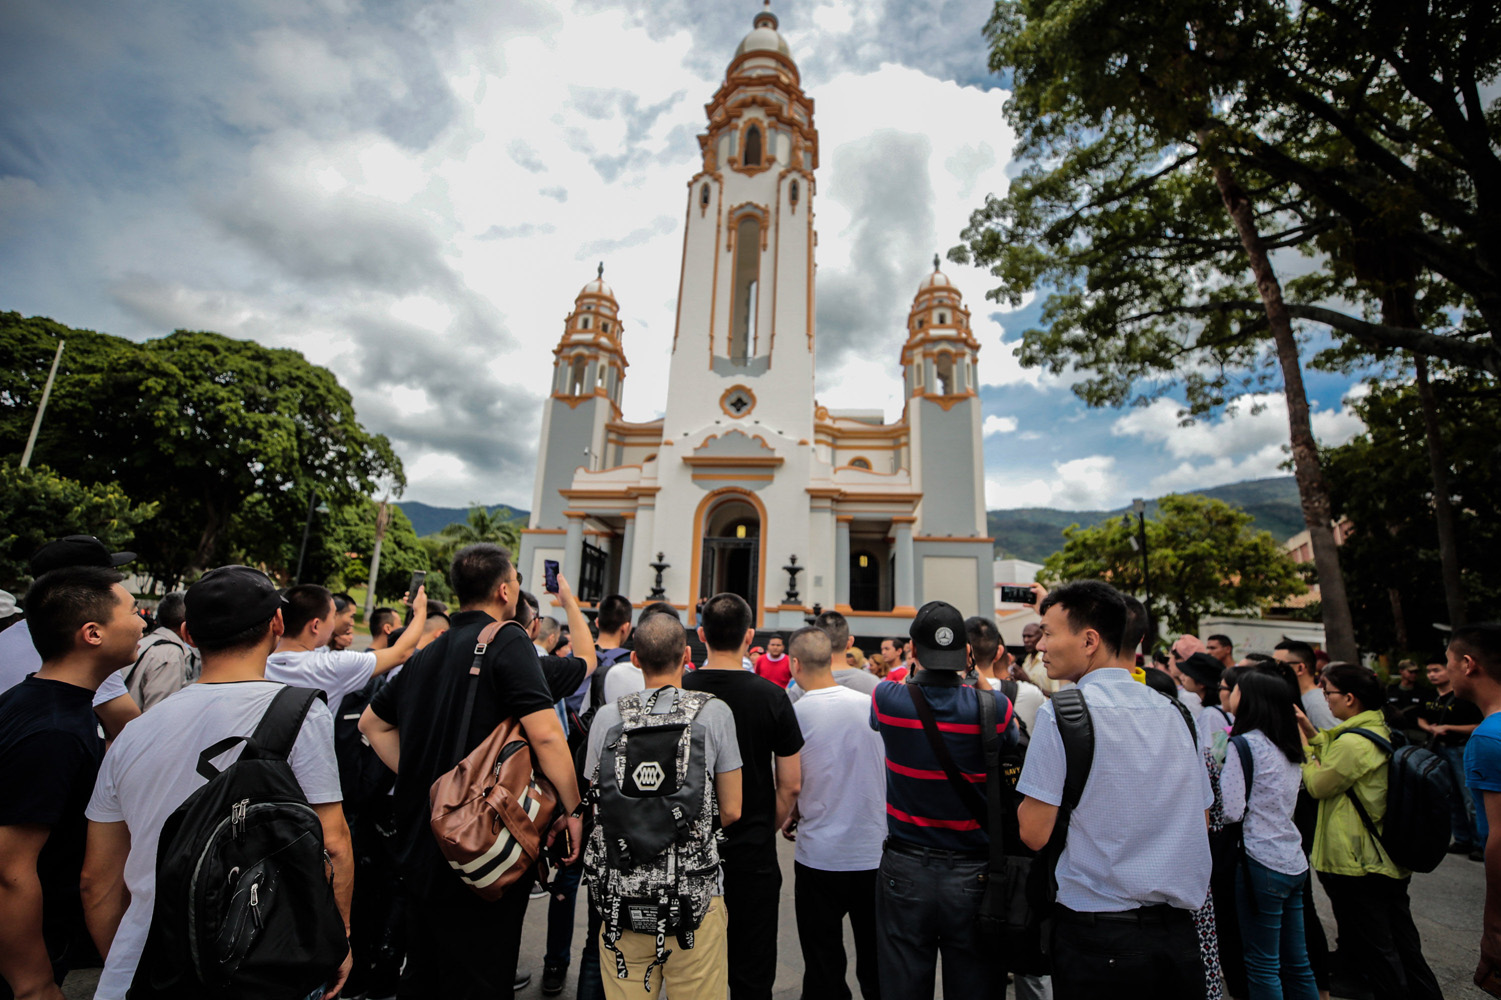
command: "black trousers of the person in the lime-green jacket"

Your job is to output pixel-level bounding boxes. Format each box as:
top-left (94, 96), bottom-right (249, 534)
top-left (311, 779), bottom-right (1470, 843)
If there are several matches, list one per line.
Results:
top-left (1318, 871), bottom-right (1442, 1000)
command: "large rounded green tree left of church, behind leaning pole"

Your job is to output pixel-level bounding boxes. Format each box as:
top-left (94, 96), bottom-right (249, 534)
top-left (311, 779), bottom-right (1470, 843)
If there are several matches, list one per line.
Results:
top-left (0, 312), bottom-right (405, 581)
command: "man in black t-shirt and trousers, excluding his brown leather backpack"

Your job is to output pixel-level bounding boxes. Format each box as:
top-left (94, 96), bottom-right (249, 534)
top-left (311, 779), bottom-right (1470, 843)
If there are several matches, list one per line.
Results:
top-left (360, 544), bottom-right (582, 1000)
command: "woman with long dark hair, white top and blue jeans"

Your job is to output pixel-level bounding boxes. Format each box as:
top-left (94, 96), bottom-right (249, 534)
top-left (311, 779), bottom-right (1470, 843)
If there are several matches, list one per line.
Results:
top-left (1220, 671), bottom-right (1318, 1000)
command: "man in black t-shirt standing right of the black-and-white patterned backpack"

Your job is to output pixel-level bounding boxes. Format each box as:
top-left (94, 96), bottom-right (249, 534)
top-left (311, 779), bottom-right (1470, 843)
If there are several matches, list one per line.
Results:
top-left (683, 593), bottom-right (804, 1000)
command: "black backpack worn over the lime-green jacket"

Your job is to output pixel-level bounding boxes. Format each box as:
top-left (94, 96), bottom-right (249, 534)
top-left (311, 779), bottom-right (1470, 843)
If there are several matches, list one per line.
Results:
top-left (1340, 728), bottom-right (1454, 872)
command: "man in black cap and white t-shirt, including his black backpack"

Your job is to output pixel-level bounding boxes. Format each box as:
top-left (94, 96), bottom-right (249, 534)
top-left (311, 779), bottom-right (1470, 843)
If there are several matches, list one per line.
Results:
top-left (83, 566), bottom-right (353, 1000)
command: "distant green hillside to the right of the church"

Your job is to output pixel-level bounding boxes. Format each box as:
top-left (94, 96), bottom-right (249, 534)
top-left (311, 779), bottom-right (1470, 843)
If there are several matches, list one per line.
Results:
top-left (986, 476), bottom-right (1303, 563)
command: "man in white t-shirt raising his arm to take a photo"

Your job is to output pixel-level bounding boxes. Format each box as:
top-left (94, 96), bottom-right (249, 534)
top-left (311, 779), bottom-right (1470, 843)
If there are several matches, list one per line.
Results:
top-left (266, 584), bottom-right (428, 710)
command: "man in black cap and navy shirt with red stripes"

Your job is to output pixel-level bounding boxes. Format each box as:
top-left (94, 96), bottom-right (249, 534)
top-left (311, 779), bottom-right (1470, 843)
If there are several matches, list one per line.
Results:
top-left (871, 601), bottom-right (1018, 1000)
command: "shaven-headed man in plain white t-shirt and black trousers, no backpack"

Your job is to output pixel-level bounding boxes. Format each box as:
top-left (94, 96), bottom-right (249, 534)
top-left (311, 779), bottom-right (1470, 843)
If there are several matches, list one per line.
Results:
top-left (784, 628), bottom-right (886, 997)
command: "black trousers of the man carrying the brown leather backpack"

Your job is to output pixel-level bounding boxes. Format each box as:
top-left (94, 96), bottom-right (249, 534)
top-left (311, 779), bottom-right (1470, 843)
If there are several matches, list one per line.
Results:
top-left (396, 874), bottom-right (533, 1000)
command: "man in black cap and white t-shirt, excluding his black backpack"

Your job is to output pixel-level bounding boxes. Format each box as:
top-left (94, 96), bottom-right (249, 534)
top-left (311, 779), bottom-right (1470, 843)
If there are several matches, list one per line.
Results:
top-left (81, 566), bottom-right (354, 1000)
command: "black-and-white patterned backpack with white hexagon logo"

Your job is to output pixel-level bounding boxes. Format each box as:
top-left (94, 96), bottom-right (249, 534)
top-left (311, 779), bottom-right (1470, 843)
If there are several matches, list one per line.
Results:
top-left (584, 688), bottom-right (722, 992)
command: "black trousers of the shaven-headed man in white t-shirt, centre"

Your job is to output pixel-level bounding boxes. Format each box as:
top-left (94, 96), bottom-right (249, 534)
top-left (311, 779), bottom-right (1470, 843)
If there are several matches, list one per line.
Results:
top-left (793, 863), bottom-right (881, 1000)
